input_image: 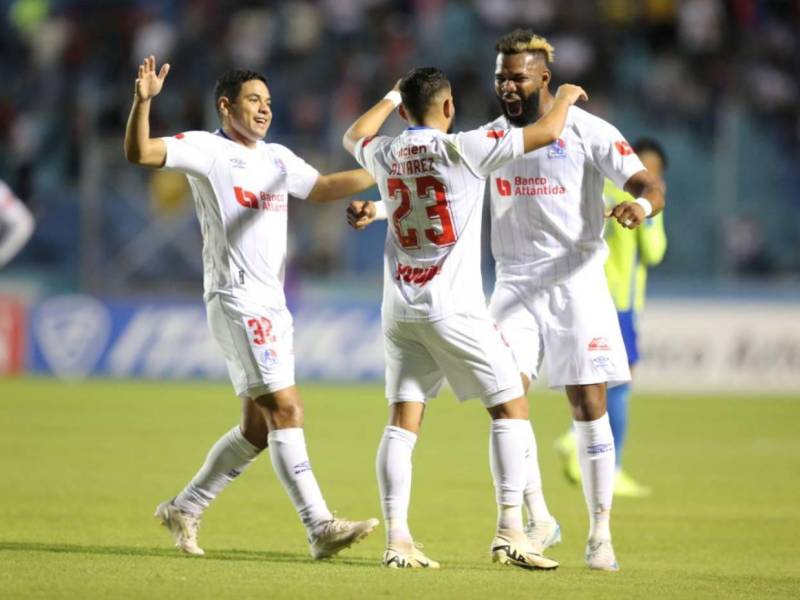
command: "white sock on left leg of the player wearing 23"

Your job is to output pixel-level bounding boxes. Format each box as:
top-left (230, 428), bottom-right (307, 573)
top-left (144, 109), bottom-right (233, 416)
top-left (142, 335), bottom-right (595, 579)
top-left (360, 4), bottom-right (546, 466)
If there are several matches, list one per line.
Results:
top-left (375, 425), bottom-right (417, 545)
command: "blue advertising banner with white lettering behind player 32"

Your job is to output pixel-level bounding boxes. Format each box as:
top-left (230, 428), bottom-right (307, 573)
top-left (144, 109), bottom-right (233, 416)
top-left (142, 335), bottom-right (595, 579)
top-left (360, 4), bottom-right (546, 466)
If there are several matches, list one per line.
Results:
top-left (28, 295), bottom-right (383, 380)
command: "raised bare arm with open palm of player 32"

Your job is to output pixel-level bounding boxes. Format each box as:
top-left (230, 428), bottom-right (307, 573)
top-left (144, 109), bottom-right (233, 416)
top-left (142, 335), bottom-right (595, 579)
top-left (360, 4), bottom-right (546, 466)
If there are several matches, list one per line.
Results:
top-left (125, 56), bottom-right (169, 167)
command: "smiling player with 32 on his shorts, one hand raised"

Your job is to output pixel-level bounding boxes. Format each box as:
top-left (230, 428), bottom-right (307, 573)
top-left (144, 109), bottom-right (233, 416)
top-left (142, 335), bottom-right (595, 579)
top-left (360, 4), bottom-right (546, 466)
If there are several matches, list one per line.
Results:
top-left (125, 56), bottom-right (378, 558)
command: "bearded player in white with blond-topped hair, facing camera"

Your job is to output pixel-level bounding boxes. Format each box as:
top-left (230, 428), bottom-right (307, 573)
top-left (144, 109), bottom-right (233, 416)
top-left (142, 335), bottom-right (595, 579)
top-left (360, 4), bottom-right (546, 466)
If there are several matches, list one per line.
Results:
top-left (485, 29), bottom-right (664, 571)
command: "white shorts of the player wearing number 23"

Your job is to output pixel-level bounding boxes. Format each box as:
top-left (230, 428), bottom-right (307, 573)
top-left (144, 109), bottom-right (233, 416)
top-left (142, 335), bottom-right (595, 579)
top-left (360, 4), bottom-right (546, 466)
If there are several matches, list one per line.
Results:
top-left (383, 312), bottom-right (524, 408)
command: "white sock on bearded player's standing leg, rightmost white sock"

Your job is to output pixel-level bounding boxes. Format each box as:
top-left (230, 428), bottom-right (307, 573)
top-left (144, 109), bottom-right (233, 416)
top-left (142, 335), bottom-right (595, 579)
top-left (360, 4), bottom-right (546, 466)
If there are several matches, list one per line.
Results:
top-left (574, 413), bottom-right (615, 540)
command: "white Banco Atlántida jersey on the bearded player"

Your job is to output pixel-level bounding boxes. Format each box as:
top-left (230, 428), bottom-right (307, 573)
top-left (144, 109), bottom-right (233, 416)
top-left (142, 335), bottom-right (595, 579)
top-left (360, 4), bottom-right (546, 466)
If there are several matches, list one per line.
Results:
top-left (484, 106), bottom-right (644, 286)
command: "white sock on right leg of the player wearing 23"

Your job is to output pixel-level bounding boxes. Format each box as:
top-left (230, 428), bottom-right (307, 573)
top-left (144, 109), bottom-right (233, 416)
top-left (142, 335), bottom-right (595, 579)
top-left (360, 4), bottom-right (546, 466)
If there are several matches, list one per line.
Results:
top-left (489, 419), bottom-right (530, 530)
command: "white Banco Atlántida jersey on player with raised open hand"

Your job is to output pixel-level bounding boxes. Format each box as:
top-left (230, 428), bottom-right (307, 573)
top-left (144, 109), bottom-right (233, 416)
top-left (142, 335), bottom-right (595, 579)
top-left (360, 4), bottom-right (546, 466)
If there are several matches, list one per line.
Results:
top-left (163, 130), bottom-right (319, 308)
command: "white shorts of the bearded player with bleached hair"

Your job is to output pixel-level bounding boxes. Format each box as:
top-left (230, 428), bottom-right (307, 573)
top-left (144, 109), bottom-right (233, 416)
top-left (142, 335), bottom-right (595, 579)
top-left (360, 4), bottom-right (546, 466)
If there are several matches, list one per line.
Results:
top-left (489, 264), bottom-right (631, 389)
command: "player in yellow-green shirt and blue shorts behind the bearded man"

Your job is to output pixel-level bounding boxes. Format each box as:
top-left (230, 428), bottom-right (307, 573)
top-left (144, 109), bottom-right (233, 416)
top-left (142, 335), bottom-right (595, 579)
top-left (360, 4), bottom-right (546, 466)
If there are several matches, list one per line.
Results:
top-left (556, 138), bottom-right (667, 498)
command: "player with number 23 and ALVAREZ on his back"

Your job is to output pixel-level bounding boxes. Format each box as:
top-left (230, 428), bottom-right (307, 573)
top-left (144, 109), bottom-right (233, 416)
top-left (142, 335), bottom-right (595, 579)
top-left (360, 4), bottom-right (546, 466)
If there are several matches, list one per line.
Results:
top-left (344, 68), bottom-right (585, 569)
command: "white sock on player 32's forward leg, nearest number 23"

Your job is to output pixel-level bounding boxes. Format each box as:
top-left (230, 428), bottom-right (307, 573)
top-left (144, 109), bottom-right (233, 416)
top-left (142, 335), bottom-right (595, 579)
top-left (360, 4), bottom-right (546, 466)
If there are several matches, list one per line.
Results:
top-left (267, 427), bottom-right (333, 535)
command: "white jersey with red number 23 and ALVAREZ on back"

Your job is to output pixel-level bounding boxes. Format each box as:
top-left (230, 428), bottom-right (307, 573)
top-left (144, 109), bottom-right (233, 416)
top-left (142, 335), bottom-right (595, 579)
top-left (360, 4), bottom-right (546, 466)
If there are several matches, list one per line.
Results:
top-left (355, 127), bottom-right (523, 321)
